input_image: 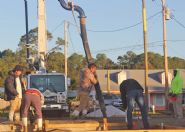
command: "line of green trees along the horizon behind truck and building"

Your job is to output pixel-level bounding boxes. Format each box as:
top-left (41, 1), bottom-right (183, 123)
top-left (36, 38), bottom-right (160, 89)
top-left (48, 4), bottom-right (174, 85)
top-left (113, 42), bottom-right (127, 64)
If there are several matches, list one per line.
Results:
top-left (0, 28), bottom-right (185, 88)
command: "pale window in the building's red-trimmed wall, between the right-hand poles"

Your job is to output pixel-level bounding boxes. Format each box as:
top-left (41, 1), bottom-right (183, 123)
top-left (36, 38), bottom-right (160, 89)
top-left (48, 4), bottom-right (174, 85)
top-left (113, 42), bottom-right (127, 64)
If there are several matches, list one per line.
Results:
top-left (154, 94), bottom-right (165, 106)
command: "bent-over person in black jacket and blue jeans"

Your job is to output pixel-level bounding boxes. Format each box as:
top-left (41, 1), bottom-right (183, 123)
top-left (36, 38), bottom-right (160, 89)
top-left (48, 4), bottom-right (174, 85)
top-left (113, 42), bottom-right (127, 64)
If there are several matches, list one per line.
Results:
top-left (120, 79), bottom-right (149, 129)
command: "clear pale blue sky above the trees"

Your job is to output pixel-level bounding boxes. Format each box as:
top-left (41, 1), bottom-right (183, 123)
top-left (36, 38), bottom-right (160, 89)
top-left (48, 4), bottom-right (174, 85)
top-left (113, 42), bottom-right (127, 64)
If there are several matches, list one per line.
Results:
top-left (0, 0), bottom-right (185, 62)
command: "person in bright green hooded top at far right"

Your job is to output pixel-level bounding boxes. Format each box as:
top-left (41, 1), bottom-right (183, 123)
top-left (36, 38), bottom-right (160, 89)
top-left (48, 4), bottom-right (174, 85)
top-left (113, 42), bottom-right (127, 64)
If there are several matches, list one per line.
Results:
top-left (169, 69), bottom-right (183, 119)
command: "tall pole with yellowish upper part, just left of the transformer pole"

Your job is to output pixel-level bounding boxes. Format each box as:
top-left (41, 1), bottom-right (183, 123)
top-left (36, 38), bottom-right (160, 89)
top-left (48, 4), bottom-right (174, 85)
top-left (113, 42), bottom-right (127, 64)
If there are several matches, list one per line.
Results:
top-left (142, 0), bottom-right (149, 106)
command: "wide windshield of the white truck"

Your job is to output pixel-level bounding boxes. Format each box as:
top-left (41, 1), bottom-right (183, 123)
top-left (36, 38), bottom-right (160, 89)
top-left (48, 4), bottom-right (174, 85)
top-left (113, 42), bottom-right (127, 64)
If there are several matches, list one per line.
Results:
top-left (30, 75), bottom-right (65, 93)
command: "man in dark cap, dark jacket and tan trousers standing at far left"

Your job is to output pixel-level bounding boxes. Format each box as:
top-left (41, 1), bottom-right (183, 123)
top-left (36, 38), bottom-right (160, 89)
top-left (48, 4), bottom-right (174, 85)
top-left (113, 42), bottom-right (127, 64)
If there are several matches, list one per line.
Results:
top-left (5, 65), bottom-right (25, 121)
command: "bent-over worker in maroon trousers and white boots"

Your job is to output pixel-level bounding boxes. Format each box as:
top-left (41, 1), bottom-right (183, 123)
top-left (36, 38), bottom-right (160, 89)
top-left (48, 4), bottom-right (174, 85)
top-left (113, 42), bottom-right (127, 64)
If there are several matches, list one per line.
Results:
top-left (21, 88), bottom-right (44, 132)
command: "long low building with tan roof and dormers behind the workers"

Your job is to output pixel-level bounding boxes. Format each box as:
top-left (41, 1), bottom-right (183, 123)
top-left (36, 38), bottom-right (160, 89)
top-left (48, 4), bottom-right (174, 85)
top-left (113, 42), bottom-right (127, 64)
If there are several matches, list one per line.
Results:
top-left (97, 69), bottom-right (185, 110)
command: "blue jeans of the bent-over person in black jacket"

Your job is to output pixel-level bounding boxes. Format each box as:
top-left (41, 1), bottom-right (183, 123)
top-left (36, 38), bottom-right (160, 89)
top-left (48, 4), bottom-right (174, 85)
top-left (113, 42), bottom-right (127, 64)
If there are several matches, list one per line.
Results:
top-left (127, 90), bottom-right (149, 129)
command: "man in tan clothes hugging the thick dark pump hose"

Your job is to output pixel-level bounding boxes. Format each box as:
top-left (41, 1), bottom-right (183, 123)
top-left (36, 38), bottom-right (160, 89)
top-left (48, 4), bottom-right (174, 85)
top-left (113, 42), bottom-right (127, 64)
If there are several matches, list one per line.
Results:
top-left (72, 63), bottom-right (97, 117)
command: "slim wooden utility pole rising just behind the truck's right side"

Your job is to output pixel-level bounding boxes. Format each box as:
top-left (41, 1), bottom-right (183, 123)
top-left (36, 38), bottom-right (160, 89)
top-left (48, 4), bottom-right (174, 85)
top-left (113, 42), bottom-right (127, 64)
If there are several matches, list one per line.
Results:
top-left (64, 21), bottom-right (68, 77)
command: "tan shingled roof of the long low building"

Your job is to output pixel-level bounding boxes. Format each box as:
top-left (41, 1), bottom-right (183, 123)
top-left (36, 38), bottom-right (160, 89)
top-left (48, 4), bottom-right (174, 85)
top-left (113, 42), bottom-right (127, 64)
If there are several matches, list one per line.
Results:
top-left (97, 70), bottom-right (185, 93)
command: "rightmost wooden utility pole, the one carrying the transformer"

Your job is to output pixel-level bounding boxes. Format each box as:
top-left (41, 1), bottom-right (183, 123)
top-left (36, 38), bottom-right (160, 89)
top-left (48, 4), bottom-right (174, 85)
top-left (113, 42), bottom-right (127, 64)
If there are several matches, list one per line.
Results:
top-left (161, 0), bottom-right (169, 105)
